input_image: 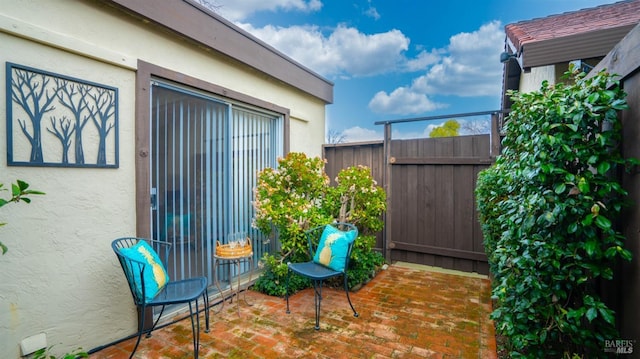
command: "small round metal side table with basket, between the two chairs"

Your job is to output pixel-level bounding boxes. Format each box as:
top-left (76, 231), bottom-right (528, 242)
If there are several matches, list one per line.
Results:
top-left (213, 240), bottom-right (254, 315)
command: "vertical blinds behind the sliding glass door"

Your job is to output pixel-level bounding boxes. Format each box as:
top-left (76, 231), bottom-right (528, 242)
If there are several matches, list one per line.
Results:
top-left (150, 82), bottom-right (284, 284)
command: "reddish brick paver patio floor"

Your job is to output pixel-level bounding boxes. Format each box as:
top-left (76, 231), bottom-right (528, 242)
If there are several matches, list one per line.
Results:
top-left (90, 264), bottom-right (497, 359)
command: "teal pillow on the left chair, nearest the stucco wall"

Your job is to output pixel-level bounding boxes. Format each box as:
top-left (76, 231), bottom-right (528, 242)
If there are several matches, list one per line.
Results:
top-left (120, 240), bottom-right (169, 303)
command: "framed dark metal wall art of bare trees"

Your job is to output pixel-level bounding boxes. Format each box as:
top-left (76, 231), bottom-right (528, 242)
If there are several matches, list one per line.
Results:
top-left (6, 63), bottom-right (118, 167)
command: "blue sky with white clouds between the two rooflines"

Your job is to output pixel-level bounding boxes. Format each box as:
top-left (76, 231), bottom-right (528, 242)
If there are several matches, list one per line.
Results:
top-left (208, 0), bottom-right (615, 142)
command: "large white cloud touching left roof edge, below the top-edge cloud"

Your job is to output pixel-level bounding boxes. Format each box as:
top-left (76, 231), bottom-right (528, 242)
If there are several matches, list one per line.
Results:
top-left (238, 24), bottom-right (409, 77)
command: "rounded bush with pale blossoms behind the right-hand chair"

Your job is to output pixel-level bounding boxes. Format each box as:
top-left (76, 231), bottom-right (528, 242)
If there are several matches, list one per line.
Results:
top-left (253, 152), bottom-right (386, 295)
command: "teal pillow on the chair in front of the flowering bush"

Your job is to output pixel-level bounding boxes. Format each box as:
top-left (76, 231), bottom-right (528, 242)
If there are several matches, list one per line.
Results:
top-left (313, 225), bottom-right (358, 272)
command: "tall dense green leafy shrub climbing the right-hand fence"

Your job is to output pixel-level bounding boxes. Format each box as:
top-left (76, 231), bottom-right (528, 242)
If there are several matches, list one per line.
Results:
top-left (476, 72), bottom-right (637, 358)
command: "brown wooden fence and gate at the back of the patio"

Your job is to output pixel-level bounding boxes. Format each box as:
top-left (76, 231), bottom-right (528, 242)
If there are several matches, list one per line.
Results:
top-left (323, 119), bottom-right (493, 274)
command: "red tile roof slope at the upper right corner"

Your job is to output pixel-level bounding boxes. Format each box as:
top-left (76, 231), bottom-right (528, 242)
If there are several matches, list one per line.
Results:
top-left (505, 0), bottom-right (640, 52)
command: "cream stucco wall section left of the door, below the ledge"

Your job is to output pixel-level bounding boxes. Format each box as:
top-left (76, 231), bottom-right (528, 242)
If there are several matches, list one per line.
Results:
top-left (0, 33), bottom-right (135, 358)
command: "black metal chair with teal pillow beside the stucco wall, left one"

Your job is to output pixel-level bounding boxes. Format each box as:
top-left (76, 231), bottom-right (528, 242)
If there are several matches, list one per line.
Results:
top-left (111, 237), bottom-right (209, 358)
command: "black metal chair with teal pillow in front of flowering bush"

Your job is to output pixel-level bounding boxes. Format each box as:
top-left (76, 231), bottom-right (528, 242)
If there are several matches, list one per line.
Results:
top-left (285, 223), bottom-right (358, 330)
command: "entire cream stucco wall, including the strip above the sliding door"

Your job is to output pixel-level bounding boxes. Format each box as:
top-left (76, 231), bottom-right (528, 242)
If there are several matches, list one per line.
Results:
top-left (0, 0), bottom-right (325, 358)
